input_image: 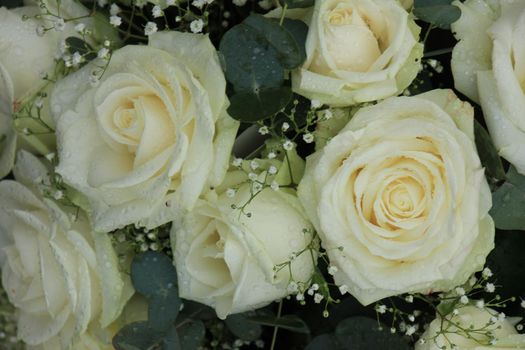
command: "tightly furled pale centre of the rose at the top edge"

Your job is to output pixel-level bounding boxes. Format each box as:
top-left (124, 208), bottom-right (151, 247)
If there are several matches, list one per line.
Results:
top-left (325, 8), bottom-right (381, 72)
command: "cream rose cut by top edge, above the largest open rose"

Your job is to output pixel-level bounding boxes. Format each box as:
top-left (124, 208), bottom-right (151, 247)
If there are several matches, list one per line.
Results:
top-left (292, 0), bottom-right (423, 106)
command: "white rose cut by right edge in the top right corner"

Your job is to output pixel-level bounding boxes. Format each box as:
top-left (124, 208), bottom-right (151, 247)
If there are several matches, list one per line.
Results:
top-left (452, 0), bottom-right (525, 174)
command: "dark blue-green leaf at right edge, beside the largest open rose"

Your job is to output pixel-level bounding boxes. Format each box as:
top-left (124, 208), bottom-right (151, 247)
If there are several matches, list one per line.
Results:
top-left (490, 166), bottom-right (525, 230)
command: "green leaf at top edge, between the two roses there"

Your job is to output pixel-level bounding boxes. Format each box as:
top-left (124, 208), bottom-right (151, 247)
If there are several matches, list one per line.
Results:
top-left (414, 0), bottom-right (461, 29)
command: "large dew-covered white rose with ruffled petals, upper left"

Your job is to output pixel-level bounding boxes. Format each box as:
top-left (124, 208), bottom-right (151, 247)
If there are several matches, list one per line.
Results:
top-left (51, 32), bottom-right (238, 231)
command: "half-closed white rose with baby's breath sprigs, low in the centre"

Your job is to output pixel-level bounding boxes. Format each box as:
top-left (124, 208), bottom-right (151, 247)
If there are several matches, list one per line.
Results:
top-left (172, 163), bottom-right (317, 319)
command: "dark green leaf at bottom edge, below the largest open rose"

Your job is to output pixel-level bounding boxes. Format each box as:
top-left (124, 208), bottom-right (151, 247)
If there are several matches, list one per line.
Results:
top-left (335, 316), bottom-right (410, 350)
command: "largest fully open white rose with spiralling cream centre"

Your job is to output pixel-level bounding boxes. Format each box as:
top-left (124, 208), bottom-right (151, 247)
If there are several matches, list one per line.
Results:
top-left (298, 90), bottom-right (494, 305)
